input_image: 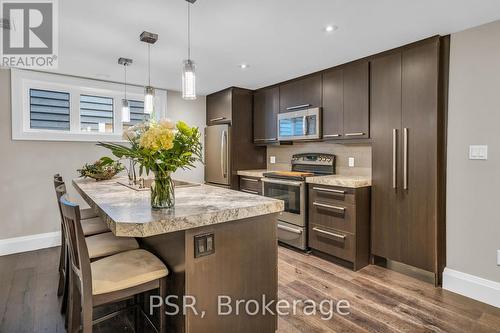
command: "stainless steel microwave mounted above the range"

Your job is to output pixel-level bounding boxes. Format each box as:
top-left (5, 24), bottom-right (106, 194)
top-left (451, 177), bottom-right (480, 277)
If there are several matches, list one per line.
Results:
top-left (278, 108), bottom-right (321, 141)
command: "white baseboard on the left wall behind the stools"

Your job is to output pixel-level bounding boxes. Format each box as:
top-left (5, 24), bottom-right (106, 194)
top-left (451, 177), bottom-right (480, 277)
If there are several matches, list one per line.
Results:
top-left (0, 231), bottom-right (61, 256)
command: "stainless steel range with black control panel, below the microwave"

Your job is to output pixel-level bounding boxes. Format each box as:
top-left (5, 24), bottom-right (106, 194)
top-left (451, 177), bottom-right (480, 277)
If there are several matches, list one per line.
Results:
top-left (262, 153), bottom-right (335, 250)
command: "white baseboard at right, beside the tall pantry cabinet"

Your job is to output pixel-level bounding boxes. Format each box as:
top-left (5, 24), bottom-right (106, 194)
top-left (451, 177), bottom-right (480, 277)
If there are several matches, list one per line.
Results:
top-left (443, 268), bottom-right (500, 308)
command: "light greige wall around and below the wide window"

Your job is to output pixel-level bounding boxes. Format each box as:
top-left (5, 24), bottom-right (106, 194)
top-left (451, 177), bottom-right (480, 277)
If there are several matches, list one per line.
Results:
top-left (0, 69), bottom-right (205, 240)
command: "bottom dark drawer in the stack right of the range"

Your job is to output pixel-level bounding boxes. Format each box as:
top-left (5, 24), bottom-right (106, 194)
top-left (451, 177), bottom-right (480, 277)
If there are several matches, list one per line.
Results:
top-left (309, 224), bottom-right (356, 262)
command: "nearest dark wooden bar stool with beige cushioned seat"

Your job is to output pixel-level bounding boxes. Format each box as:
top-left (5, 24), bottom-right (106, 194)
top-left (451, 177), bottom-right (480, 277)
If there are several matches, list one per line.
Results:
top-left (60, 195), bottom-right (168, 333)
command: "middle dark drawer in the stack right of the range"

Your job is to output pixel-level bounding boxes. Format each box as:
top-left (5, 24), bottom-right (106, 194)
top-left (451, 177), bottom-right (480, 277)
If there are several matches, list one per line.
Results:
top-left (309, 201), bottom-right (356, 234)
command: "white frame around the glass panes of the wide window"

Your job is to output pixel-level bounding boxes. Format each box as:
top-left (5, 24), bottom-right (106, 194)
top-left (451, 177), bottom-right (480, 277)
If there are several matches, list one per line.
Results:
top-left (11, 69), bottom-right (167, 142)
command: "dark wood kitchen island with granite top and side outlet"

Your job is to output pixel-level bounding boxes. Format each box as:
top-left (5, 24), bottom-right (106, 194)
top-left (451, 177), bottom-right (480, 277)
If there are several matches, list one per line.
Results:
top-left (73, 179), bottom-right (284, 332)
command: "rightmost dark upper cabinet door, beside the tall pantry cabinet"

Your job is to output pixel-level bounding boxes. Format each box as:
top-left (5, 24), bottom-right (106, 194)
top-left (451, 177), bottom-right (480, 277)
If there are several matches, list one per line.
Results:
top-left (343, 60), bottom-right (370, 139)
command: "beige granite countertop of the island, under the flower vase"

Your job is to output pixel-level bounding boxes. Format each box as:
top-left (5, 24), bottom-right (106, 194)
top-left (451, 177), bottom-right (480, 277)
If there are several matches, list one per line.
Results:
top-left (73, 178), bottom-right (284, 237)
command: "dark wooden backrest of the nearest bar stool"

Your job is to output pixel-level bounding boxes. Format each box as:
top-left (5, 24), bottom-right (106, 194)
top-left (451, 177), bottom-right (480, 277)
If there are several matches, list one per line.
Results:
top-left (56, 185), bottom-right (92, 301)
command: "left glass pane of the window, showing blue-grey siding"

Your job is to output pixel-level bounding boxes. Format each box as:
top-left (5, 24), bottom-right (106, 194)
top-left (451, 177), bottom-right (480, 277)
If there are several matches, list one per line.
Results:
top-left (30, 89), bottom-right (69, 131)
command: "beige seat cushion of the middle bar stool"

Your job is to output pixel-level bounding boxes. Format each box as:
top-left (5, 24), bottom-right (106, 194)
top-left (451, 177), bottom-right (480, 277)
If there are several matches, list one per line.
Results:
top-left (85, 232), bottom-right (139, 259)
